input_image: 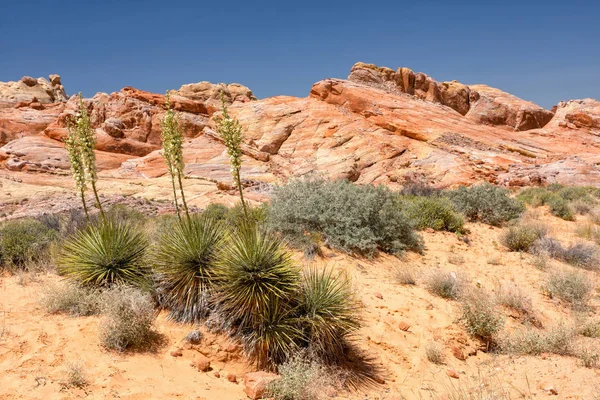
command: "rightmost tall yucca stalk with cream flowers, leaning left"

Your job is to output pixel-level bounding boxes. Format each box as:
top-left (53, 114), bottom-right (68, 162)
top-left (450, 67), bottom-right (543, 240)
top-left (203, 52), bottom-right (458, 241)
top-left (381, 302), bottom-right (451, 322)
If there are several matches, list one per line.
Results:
top-left (217, 93), bottom-right (248, 219)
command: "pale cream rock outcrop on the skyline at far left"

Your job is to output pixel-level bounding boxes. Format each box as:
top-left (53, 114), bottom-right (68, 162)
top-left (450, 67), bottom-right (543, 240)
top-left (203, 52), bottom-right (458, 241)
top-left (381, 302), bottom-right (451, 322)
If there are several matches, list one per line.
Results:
top-left (0, 75), bottom-right (67, 109)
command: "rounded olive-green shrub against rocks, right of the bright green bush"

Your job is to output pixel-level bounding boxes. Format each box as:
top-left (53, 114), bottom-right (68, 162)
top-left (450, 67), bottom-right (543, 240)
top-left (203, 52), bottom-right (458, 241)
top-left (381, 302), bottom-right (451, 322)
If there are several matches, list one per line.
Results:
top-left (446, 183), bottom-right (525, 226)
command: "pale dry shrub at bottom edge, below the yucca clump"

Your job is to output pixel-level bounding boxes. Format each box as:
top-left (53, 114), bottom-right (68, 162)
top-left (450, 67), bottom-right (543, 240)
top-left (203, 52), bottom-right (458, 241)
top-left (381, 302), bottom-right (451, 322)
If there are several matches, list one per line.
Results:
top-left (267, 354), bottom-right (340, 400)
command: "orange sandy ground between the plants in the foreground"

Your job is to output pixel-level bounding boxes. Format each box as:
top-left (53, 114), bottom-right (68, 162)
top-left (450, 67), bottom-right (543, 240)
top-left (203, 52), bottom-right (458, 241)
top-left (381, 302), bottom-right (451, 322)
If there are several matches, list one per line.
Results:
top-left (0, 205), bottom-right (600, 400)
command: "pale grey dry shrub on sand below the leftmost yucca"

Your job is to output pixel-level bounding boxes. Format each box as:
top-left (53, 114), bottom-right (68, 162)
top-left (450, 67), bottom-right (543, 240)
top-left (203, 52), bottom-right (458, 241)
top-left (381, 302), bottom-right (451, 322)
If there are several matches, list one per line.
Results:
top-left (100, 286), bottom-right (160, 351)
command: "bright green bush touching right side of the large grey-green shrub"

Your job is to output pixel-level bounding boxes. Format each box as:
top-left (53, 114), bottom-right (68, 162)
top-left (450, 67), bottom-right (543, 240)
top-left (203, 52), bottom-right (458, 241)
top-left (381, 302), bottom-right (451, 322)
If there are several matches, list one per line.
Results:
top-left (404, 197), bottom-right (464, 233)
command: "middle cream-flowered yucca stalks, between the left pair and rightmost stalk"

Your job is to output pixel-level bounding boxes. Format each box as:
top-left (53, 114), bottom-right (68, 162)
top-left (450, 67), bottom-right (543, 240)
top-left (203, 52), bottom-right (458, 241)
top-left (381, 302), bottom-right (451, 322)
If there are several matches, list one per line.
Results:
top-left (160, 92), bottom-right (190, 221)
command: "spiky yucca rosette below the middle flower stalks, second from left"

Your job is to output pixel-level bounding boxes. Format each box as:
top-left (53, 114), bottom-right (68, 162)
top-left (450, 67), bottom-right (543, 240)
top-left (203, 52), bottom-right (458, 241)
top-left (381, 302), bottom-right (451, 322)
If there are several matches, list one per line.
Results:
top-left (154, 214), bottom-right (225, 322)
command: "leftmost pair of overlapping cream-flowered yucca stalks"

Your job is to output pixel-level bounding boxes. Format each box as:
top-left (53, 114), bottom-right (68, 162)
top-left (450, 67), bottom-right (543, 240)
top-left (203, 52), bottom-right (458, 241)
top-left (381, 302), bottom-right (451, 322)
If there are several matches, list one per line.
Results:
top-left (65, 93), bottom-right (106, 221)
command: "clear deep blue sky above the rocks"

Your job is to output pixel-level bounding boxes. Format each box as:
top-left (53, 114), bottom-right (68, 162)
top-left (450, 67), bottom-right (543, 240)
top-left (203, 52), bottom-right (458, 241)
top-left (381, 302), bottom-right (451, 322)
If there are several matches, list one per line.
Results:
top-left (0, 0), bottom-right (600, 107)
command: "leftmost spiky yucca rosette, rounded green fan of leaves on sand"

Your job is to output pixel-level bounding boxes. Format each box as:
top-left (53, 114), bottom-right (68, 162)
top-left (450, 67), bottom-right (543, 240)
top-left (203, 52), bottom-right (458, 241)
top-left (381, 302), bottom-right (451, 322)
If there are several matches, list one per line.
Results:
top-left (58, 220), bottom-right (149, 286)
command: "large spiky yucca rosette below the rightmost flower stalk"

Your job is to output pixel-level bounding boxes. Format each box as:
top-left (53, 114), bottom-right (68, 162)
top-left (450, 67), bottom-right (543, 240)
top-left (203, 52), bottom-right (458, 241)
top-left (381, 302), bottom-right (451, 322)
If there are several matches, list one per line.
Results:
top-left (216, 222), bottom-right (300, 326)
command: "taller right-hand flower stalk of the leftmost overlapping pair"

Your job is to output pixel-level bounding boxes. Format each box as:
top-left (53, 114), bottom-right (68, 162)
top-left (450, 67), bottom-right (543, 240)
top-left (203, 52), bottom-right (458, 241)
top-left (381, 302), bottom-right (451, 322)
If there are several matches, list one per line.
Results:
top-left (67, 93), bottom-right (106, 221)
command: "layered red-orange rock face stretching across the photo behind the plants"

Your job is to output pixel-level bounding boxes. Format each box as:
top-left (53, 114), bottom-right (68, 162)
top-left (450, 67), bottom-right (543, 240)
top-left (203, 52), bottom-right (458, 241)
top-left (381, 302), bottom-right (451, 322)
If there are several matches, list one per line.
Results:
top-left (0, 63), bottom-right (600, 194)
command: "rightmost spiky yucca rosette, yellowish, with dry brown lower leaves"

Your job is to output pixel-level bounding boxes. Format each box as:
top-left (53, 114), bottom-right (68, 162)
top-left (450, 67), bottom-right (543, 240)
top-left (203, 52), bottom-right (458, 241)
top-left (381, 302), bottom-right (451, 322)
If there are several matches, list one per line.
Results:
top-left (299, 267), bottom-right (360, 360)
